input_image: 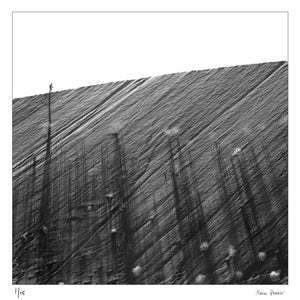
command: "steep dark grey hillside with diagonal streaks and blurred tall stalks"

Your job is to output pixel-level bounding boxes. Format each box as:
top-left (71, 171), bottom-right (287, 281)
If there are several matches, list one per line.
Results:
top-left (13, 62), bottom-right (288, 283)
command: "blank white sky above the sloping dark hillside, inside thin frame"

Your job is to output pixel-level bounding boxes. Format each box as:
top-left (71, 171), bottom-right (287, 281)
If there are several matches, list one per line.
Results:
top-left (13, 13), bottom-right (287, 98)
